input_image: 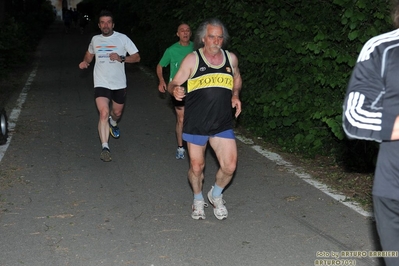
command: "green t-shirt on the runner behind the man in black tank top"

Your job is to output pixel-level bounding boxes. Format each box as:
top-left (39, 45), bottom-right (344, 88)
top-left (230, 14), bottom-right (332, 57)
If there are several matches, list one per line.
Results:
top-left (159, 41), bottom-right (194, 81)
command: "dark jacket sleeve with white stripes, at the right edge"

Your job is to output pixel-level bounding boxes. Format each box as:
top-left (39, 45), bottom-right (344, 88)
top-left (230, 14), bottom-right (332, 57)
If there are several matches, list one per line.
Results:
top-left (343, 39), bottom-right (396, 142)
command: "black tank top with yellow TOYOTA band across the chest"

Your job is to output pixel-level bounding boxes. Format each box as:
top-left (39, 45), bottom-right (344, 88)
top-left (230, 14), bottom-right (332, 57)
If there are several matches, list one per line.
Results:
top-left (183, 49), bottom-right (233, 136)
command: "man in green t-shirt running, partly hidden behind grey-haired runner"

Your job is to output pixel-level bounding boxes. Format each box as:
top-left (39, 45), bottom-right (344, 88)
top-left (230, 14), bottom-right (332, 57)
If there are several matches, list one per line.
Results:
top-left (157, 23), bottom-right (193, 159)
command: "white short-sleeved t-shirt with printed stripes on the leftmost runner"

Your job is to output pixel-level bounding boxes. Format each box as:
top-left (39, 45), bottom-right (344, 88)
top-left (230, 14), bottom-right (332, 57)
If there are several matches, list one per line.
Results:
top-left (88, 31), bottom-right (139, 90)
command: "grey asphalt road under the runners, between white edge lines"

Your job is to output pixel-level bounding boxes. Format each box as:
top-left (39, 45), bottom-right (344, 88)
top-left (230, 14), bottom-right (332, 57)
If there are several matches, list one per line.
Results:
top-left (0, 22), bottom-right (388, 266)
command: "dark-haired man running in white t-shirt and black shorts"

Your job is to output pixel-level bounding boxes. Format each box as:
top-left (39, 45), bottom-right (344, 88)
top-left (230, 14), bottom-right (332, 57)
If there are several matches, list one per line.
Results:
top-left (79, 11), bottom-right (140, 162)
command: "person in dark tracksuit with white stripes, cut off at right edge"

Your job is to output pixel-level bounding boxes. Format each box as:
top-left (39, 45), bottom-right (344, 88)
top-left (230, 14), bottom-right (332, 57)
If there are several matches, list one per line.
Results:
top-left (343, 1), bottom-right (399, 266)
